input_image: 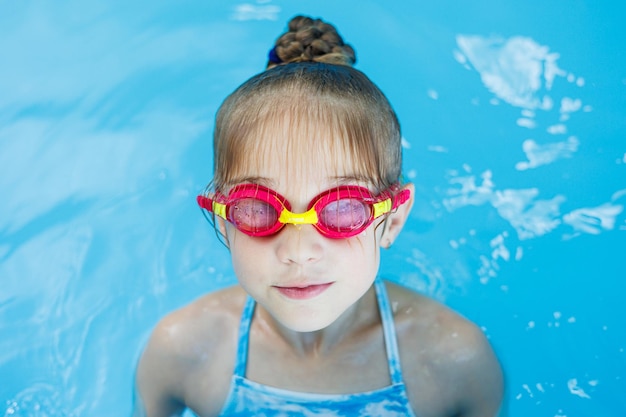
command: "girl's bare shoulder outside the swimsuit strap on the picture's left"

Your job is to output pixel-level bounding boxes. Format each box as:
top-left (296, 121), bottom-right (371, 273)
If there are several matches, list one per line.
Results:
top-left (136, 287), bottom-right (246, 415)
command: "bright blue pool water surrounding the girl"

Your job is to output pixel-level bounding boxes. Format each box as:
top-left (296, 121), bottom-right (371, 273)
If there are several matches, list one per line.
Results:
top-left (0, 0), bottom-right (626, 417)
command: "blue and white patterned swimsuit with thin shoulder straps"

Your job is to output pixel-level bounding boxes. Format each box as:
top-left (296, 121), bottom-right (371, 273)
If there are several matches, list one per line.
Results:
top-left (220, 279), bottom-right (415, 417)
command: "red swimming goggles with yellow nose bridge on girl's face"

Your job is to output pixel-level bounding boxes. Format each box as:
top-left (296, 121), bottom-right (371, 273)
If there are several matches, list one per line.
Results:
top-left (197, 184), bottom-right (411, 239)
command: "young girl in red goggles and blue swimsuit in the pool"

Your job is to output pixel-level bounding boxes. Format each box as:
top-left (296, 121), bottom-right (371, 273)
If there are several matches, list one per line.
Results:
top-left (135, 17), bottom-right (502, 417)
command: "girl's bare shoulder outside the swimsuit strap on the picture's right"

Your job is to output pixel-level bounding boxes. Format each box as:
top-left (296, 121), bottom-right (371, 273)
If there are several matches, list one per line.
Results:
top-left (387, 283), bottom-right (502, 415)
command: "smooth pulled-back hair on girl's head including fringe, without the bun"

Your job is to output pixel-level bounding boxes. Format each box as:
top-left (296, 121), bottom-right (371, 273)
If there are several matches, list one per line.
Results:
top-left (212, 62), bottom-right (402, 191)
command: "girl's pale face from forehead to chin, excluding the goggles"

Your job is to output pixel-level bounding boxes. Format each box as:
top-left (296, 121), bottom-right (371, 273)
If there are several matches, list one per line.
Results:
top-left (220, 130), bottom-right (398, 332)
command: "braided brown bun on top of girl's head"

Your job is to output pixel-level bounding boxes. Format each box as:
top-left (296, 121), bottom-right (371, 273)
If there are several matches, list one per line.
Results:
top-left (267, 16), bottom-right (356, 69)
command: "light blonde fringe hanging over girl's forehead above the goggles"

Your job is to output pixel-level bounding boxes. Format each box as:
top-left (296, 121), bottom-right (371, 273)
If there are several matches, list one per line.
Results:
top-left (214, 95), bottom-right (382, 189)
